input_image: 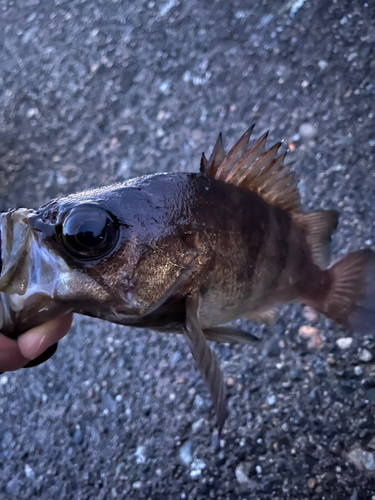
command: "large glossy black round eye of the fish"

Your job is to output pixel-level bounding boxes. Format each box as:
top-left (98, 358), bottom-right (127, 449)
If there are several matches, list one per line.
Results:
top-left (59, 205), bottom-right (118, 260)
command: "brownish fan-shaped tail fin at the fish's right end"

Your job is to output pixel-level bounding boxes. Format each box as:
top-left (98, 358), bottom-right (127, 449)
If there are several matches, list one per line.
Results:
top-left (319, 249), bottom-right (375, 333)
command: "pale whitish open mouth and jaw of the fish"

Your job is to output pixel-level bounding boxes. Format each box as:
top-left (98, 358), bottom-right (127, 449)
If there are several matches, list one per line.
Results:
top-left (0, 208), bottom-right (75, 336)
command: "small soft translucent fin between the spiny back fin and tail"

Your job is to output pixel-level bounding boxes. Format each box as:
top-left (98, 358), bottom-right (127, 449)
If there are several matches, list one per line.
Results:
top-left (293, 210), bottom-right (339, 269)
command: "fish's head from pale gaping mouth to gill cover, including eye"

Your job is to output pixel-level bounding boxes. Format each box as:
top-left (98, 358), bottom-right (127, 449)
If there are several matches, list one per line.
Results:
top-left (0, 176), bottom-right (195, 331)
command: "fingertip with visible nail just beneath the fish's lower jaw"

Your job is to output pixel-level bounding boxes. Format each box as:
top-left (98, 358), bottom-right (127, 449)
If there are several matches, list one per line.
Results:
top-left (18, 314), bottom-right (73, 359)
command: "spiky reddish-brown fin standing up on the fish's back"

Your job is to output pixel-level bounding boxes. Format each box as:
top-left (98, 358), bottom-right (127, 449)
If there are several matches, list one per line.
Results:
top-left (201, 125), bottom-right (300, 213)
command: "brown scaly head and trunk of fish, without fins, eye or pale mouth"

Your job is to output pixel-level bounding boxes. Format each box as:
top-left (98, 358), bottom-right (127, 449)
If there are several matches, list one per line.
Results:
top-left (2, 173), bottom-right (323, 335)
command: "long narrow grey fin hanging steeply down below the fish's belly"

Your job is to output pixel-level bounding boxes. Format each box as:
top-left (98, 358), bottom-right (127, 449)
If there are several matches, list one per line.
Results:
top-left (184, 295), bottom-right (227, 435)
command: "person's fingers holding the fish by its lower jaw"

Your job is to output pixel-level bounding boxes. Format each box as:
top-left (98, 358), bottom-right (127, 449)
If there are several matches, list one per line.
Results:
top-left (0, 314), bottom-right (73, 372)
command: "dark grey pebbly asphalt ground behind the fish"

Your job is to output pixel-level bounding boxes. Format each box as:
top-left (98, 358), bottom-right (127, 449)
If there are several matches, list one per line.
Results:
top-left (0, 0), bottom-right (375, 500)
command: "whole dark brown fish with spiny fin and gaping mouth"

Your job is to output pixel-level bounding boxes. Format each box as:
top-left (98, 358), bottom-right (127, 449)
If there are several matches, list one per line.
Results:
top-left (0, 126), bottom-right (375, 432)
